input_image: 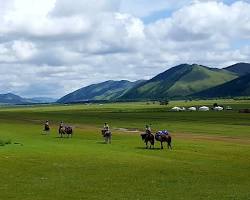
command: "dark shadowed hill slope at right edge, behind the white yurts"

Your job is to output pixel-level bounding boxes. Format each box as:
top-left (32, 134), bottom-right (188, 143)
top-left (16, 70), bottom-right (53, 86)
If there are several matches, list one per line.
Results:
top-left (192, 74), bottom-right (250, 98)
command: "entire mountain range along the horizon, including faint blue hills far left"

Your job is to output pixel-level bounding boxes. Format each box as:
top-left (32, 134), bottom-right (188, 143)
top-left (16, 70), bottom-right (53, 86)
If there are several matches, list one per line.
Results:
top-left (0, 63), bottom-right (250, 104)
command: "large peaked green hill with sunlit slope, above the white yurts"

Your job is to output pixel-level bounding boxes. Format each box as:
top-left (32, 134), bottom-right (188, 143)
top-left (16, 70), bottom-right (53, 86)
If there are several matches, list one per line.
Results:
top-left (120, 64), bottom-right (237, 99)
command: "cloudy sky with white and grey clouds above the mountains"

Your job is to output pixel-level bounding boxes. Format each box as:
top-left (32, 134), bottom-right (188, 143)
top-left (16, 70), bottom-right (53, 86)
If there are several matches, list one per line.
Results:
top-left (0, 0), bottom-right (250, 98)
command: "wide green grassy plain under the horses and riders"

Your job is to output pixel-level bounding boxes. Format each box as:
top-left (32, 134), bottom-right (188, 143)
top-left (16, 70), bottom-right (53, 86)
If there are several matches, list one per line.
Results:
top-left (0, 100), bottom-right (250, 200)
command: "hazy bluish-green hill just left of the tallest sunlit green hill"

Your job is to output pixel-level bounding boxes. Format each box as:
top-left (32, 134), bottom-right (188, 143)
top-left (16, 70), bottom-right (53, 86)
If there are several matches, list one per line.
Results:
top-left (57, 80), bottom-right (144, 103)
